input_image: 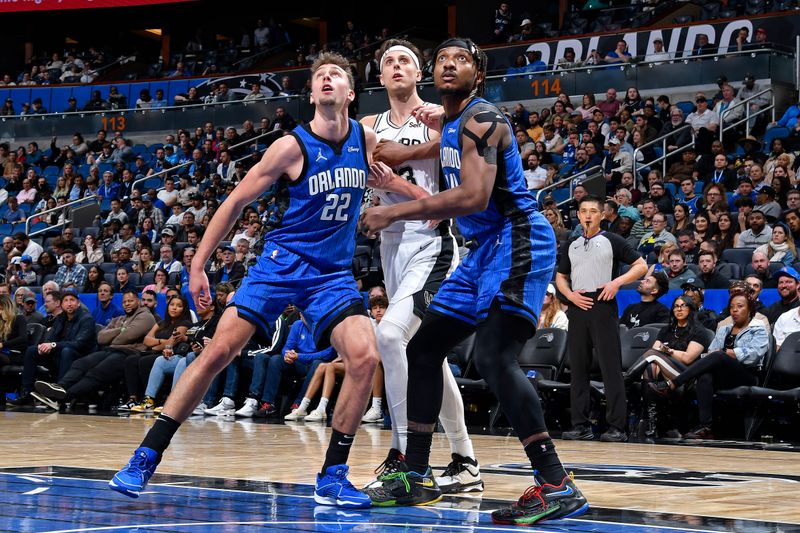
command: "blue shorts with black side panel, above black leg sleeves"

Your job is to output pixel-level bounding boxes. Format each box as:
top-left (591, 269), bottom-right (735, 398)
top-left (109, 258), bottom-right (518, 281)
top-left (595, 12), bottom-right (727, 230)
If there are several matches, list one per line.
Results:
top-left (429, 212), bottom-right (557, 327)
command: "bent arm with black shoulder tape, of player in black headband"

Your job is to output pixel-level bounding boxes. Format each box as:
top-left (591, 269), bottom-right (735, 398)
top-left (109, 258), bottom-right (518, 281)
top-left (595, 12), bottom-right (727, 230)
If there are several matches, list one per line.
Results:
top-left (362, 112), bottom-right (504, 233)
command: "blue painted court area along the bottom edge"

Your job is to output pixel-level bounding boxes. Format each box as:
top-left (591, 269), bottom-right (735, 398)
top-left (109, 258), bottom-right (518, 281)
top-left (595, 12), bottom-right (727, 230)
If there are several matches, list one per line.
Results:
top-left (0, 467), bottom-right (785, 533)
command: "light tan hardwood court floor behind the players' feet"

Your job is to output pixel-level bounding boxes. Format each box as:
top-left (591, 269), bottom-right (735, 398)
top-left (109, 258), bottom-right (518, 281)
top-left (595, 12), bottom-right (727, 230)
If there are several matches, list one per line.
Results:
top-left (0, 412), bottom-right (800, 531)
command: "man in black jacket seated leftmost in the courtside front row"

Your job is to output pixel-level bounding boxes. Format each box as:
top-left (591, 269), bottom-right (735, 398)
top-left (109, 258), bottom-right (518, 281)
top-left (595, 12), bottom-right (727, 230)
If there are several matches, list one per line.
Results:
top-left (10, 289), bottom-right (97, 406)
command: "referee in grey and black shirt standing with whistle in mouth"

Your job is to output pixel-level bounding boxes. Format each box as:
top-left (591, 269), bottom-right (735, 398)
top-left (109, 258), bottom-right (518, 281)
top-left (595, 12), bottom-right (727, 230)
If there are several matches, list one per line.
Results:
top-left (556, 196), bottom-right (647, 442)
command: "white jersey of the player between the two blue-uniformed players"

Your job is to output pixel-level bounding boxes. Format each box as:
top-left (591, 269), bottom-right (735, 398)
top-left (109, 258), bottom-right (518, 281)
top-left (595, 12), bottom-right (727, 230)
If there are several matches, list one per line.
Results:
top-left (372, 103), bottom-right (439, 235)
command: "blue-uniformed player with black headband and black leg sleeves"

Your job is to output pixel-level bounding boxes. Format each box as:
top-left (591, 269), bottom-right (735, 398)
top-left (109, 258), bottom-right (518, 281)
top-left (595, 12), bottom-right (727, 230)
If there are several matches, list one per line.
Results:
top-left (361, 39), bottom-right (589, 525)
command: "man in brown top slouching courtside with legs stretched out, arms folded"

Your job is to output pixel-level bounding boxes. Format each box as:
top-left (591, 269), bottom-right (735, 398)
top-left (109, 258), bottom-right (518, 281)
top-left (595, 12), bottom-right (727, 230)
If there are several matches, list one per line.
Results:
top-left (36, 290), bottom-right (155, 409)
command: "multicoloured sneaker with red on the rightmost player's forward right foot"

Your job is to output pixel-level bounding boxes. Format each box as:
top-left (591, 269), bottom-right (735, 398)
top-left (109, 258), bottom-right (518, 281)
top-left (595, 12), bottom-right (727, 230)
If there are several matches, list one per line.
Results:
top-left (492, 476), bottom-right (589, 526)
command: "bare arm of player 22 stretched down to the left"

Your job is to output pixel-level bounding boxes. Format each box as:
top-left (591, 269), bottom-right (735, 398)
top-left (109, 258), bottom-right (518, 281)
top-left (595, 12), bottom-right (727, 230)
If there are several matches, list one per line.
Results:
top-left (190, 136), bottom-right (303, 307)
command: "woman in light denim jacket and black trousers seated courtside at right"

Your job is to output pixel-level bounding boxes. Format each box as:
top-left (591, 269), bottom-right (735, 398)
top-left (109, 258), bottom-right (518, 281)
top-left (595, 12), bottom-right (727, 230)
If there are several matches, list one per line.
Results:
top-left (668, 291), bottom-right (769, 439)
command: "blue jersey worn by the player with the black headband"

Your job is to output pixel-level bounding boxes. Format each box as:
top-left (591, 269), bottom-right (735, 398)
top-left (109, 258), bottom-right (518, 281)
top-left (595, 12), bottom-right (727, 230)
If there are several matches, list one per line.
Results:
top-left (441, 98), bottom-right (537, 243)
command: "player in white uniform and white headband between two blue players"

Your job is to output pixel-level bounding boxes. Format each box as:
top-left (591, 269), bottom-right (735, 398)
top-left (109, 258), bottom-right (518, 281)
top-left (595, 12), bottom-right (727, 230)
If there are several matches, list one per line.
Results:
top-left (361, 39), bottom-right (483, 493)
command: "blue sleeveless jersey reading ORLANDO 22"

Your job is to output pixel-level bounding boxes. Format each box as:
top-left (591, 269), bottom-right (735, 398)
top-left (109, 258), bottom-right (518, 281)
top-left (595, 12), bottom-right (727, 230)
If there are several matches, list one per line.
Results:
top-left (264, 119), bottom-right (369, 272)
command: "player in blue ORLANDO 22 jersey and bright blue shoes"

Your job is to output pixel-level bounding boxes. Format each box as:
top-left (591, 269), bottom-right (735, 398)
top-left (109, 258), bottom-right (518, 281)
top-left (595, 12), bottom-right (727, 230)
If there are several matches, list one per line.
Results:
top-left (109, 54), bottom-right (405, 507)
